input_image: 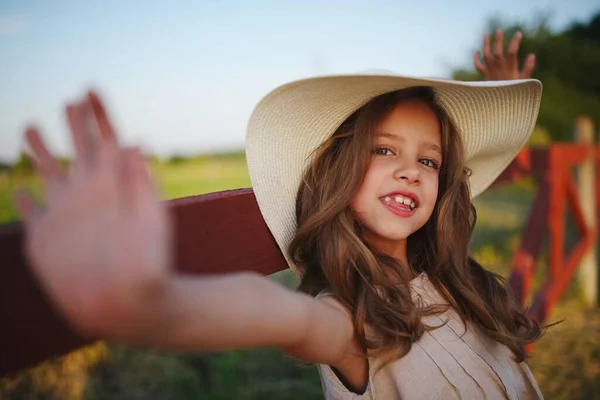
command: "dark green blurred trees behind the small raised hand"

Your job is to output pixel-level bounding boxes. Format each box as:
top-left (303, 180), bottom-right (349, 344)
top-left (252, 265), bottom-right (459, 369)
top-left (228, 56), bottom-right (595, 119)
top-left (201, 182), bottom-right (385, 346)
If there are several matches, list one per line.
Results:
top-left (452, 13), bottom-right (600, 141)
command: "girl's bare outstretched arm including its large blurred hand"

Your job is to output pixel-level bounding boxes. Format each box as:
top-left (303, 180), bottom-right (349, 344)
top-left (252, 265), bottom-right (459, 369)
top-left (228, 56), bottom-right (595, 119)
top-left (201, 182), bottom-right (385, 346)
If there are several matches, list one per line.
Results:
top-left (17, 94), bottom-right (353, 365)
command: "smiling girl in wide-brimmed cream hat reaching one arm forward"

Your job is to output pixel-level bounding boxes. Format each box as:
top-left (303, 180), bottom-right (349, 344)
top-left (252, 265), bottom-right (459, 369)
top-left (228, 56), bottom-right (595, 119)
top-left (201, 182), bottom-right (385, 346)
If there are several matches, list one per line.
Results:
top-left (17, 35), bottom-right (542, 400)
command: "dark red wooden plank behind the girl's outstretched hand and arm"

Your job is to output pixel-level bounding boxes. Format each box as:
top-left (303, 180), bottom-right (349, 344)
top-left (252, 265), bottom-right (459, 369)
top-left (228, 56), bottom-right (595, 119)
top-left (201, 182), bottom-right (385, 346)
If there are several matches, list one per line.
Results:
top-left (0, 189), bottom-right (287, 376)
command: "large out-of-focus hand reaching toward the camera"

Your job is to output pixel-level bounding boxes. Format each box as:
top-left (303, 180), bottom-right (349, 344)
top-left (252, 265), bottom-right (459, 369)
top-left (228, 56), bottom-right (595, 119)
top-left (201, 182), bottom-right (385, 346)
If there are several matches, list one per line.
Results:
top-left (15, 93), bottom-right (171, 336)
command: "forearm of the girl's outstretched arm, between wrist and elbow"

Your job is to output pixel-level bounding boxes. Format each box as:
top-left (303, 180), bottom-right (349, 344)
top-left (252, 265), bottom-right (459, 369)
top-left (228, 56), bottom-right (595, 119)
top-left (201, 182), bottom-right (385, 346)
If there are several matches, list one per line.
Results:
top-left (141, 273), bottom-right (311, 351)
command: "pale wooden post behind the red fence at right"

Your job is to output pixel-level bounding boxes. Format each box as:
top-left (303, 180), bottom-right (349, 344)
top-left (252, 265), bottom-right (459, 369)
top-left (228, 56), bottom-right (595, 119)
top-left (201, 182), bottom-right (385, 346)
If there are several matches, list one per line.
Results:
top-left (575, 116), bottom-right (598, 307)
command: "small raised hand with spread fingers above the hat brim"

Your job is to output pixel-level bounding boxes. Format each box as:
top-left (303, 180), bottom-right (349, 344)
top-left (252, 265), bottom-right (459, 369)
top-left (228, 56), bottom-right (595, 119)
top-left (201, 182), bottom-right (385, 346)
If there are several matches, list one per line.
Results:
top-left (474, 29), bottom-right (535, 81)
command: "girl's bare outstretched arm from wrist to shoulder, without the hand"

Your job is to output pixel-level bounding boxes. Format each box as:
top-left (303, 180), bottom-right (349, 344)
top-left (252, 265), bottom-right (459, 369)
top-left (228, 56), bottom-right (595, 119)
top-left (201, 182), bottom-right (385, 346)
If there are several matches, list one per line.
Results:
top-left (144, 273), bottom-right (354, 365)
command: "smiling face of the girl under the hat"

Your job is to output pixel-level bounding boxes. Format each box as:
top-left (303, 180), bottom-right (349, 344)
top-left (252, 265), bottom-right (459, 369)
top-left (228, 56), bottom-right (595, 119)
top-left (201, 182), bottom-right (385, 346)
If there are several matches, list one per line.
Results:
top-left (351, 101), bottom-right (442, 261)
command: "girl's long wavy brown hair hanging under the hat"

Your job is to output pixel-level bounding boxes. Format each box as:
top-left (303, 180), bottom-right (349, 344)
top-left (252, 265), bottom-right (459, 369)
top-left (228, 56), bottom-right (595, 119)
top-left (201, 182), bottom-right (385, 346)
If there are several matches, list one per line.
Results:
top-left (289, 87), bottom-right (541, 363)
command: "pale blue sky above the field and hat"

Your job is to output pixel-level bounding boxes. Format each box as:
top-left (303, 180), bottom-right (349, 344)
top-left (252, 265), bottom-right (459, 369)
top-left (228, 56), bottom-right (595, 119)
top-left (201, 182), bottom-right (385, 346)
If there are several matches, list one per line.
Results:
top-left (0, 0), bottom-right (600, 162)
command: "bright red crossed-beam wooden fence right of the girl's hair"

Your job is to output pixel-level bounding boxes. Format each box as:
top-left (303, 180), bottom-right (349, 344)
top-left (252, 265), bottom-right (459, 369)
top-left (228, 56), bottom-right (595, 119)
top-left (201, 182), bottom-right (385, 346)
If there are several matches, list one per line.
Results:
top-left (496, 144), bottom-right (600, 321)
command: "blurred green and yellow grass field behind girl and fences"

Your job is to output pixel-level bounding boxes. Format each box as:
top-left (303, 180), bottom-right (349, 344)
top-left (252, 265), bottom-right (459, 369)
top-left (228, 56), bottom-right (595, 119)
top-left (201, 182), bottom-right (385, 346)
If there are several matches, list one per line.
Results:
top-left (0, 156), bottom-right (600, 400)
